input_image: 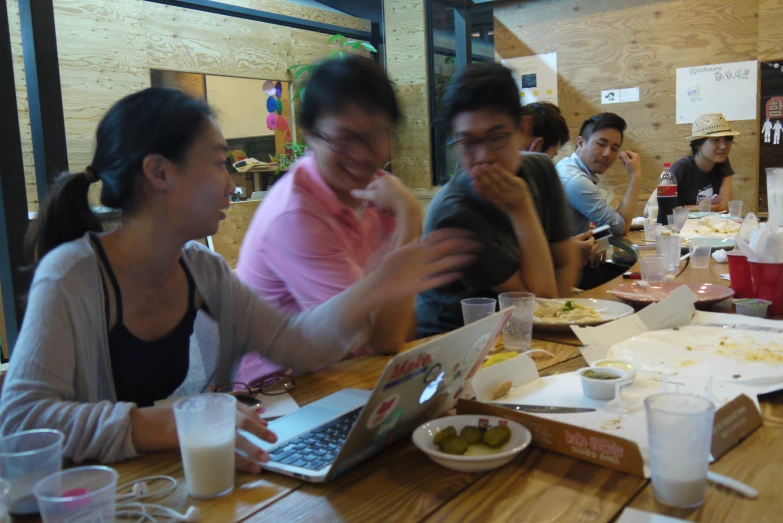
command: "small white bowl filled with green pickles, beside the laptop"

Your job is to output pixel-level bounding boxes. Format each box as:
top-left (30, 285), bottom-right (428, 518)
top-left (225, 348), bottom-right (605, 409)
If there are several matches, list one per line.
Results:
top-left (412, 414), bottom-right (533, 472)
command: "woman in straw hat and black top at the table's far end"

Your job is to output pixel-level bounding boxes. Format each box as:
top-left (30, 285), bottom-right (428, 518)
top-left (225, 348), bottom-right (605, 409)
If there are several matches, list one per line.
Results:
top-left (671, 113), bottom-right (740, 212)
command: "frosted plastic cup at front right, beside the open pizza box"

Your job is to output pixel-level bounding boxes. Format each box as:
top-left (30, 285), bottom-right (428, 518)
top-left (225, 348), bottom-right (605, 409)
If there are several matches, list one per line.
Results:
top-left (644, 393), bottom-right (715, 508)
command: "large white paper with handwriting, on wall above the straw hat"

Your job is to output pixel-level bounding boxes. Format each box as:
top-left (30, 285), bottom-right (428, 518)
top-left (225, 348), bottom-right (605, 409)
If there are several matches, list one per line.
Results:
top-left (676, 60), bottom-right (758, 123)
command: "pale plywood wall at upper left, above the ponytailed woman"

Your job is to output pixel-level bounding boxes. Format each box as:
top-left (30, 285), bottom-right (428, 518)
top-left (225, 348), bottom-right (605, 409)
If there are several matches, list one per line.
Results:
top-left (5, 0), bottom-right (370, 210)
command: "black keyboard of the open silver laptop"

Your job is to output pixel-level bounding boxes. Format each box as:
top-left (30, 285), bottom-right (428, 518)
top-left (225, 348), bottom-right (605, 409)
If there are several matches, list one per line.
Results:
top-left (269, 406), bottom-right (364, 470)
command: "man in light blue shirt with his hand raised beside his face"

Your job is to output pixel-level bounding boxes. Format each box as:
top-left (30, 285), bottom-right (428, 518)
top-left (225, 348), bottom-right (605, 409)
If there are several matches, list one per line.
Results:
top-left (557, 113), bottom-right (642, 236)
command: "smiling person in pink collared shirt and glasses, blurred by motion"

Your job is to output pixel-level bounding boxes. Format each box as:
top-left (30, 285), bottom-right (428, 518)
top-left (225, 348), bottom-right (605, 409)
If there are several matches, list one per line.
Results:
top-left (236, 55), bottom-right (422, 382)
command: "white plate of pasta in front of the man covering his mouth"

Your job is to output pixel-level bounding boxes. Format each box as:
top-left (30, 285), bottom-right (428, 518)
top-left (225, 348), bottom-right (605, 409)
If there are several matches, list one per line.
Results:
top-left (533, 298), bottom-right (633, 332)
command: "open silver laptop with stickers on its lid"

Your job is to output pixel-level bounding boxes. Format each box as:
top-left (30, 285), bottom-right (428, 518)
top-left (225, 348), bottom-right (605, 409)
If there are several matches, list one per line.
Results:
top-left (247, 309), bottom-right (512, 483)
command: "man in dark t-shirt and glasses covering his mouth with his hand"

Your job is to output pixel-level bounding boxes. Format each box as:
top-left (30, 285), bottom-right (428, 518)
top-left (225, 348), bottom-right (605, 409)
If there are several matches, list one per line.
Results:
top-left (416, 63), bottom-right (582, 336)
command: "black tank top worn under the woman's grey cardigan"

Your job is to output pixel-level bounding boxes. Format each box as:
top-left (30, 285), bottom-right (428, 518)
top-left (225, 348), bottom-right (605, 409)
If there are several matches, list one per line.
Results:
top-left (90, 234), bottom-right (198, 407)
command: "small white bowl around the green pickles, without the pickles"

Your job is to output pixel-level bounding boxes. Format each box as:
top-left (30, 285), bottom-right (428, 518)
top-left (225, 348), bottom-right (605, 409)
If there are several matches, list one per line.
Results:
top-left (412, 414), bottom-right (533, 472)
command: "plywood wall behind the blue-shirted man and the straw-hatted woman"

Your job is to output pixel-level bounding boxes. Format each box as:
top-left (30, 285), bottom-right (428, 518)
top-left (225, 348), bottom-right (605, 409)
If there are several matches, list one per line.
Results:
top-left (495, 0), bottom-right (764, 213)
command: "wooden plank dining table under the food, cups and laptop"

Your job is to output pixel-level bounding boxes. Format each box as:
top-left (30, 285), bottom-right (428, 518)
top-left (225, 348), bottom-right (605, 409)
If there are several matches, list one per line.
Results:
top-left (13, 231), bottom-right (783, 522)
